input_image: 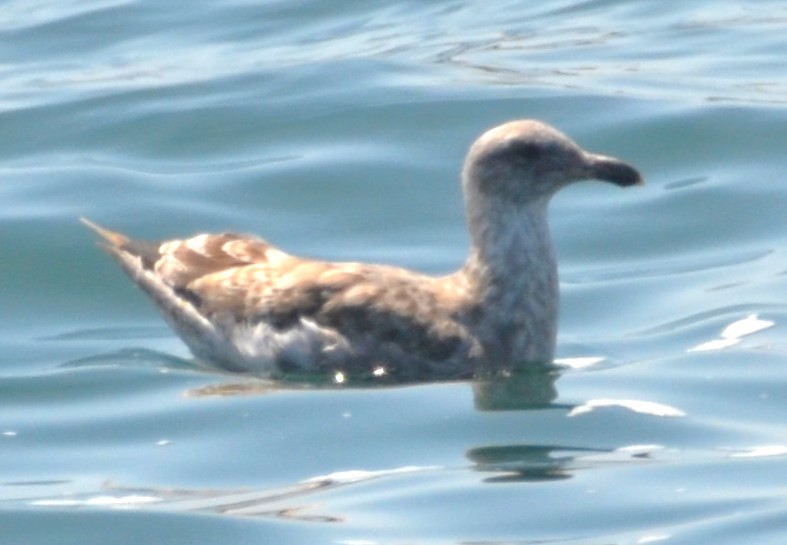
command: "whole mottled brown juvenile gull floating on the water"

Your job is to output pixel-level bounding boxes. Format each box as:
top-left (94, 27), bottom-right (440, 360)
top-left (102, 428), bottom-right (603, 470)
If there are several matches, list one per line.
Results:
top-left (82, 120), bottom-right (642, 380)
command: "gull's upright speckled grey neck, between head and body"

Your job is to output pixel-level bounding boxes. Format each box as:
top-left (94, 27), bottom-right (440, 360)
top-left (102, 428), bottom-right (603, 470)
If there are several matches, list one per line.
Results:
top-left (460, 197), bottom-right (559, 369)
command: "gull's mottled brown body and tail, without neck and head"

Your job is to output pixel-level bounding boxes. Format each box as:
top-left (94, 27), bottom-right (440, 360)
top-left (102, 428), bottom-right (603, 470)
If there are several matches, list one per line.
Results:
top-left (85, 221), bottom-right (478, 380)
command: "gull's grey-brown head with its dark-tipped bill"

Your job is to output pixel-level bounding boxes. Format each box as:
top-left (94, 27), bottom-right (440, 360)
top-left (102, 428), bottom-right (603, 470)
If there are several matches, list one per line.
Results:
top-left (462, 119), bottom-right (642, 205)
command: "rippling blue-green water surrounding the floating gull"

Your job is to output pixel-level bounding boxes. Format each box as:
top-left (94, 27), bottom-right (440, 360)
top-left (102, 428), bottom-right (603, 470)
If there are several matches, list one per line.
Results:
top-left (0, 0), bottom-right (787, 545)
